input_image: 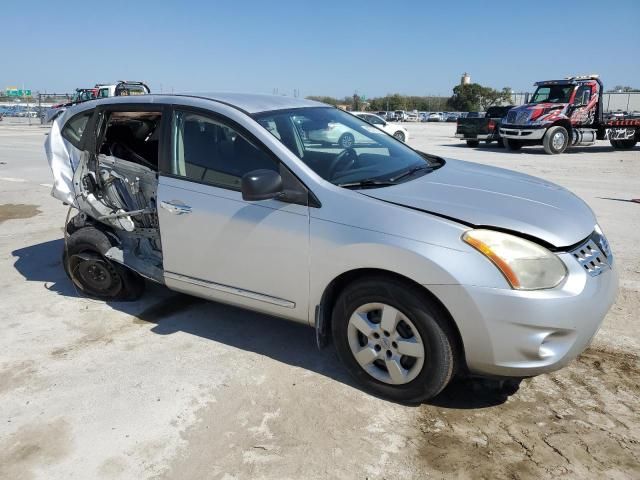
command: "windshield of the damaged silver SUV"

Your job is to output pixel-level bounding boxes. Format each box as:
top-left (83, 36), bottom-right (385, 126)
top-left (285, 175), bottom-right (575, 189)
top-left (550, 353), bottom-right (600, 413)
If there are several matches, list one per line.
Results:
top-left (254, 107), bottom-right (444, 188)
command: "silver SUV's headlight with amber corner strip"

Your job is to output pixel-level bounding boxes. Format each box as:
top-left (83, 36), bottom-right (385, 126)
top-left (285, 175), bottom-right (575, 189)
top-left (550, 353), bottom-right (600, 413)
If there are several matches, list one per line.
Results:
top-left (462, 229), bottom-right (567, 290)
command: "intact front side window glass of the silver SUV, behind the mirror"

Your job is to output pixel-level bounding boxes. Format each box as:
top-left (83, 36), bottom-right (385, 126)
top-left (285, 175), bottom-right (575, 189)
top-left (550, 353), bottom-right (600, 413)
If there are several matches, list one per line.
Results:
top-left (171, 111), bottom-right (278, 190)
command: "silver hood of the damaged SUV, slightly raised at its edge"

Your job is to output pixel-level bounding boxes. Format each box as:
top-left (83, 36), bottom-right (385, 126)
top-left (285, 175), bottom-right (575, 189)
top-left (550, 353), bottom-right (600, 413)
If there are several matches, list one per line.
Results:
top-left (360, 160), bottom-right (596, 247)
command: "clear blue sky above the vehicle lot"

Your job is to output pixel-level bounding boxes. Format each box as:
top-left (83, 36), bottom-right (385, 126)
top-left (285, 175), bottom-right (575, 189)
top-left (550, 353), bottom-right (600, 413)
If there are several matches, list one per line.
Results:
top-left (5, 0), bottom-right (640, 97)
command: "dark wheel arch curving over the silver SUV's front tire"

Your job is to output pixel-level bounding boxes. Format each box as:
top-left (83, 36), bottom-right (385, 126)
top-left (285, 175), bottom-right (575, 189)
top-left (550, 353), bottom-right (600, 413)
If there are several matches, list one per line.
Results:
top-left (315, 268), bottom-right (466, 368)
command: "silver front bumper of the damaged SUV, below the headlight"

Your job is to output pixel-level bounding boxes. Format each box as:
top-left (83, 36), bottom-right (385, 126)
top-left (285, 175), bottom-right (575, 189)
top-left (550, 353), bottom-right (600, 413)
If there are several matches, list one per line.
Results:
top-left (428, 253), bottom-right (618, 377)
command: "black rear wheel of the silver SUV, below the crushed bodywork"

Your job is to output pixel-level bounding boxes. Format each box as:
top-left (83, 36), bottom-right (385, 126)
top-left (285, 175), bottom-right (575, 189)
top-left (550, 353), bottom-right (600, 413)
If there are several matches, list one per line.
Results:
top-left (62, 226), bottom-right (145, 300)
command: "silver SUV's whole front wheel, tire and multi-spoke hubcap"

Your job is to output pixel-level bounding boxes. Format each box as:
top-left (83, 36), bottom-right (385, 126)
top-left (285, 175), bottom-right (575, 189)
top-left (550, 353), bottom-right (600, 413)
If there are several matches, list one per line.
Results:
top-left (331, 277), bottom-right (456, 402)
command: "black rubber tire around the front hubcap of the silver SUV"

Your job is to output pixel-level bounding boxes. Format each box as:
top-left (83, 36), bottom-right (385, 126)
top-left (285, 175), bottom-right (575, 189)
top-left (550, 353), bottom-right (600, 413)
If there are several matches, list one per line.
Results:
top-left (331, 276), bottom-right (458, 403)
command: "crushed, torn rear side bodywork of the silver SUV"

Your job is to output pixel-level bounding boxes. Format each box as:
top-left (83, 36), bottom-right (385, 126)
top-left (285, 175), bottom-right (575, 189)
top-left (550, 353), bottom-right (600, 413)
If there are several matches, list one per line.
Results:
top-left (45, 107), bottom-right (164, 283)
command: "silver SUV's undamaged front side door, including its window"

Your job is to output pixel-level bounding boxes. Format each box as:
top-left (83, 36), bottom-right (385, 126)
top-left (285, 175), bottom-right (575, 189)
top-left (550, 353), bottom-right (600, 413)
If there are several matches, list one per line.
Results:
top-left (158, 107), bottom-right (309, 322)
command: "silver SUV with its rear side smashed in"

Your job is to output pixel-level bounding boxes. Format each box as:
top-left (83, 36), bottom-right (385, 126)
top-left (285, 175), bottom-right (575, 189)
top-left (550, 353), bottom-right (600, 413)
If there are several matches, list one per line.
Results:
top-left (46, 94), bottom-right (617, 401)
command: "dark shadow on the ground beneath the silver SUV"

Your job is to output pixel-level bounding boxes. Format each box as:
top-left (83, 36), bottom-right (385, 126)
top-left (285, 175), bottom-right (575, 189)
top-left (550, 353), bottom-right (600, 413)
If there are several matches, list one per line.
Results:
top-left (12, 239), bottom-right (508, 409)
